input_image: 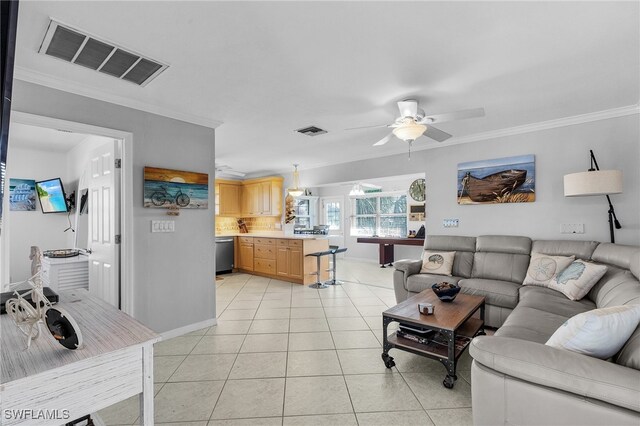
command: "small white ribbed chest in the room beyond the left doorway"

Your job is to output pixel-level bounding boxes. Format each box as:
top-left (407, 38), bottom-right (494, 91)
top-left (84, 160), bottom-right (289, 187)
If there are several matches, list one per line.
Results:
top-left (41, 254), bottom-right (89, 293)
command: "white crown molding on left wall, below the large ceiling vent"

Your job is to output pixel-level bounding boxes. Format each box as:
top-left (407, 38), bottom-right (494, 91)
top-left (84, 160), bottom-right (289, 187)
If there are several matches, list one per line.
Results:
top-left (14, 66), bottom-right (223, 129)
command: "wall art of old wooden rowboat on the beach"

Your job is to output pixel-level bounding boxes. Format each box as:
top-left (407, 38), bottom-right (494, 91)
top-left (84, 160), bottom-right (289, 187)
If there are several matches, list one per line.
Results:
top-left (457, 155), bottom-right (536, 204)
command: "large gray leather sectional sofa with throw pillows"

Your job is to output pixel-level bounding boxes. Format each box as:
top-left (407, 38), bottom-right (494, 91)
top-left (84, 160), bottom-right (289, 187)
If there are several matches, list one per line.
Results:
top-left (394, 235), bottom-right (640, 426)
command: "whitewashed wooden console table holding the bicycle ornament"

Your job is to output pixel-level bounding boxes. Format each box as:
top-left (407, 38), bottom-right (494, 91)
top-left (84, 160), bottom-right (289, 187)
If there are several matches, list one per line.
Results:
top-left (0, 289), bottom-right (159, 426)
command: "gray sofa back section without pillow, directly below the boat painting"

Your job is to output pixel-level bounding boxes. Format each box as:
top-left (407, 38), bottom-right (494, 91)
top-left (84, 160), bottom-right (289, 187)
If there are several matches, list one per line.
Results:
top-left (471, 235), bottom-right (531, 284)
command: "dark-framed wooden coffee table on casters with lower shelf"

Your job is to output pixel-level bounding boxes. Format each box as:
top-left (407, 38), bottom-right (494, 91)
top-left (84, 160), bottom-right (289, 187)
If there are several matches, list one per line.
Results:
top-left (382, 289), bottom-right (484, 389)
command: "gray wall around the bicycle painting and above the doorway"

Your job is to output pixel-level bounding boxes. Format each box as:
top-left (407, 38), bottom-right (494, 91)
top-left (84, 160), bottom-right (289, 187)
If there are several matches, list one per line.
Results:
top-left (13, 81), bottom-right (215, 332)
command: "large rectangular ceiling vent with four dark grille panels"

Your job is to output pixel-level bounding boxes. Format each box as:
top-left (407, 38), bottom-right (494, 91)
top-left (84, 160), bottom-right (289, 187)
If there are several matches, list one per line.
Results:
top-left (38, 19), bottom-right (168, 86)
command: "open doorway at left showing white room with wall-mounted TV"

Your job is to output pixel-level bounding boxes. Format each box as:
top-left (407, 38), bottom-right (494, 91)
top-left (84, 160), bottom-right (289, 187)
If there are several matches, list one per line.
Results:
top-left (0, 112), bottom-right (133, 315)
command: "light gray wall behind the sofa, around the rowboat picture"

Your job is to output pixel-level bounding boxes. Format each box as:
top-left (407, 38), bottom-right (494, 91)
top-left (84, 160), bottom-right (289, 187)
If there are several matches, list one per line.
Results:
top-left (301, 114), bottom-right (640, 245)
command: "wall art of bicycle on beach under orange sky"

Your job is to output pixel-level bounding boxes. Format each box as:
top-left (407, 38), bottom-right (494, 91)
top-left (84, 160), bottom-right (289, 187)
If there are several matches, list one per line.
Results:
top-left (144, 167), bottom-right (209, 209)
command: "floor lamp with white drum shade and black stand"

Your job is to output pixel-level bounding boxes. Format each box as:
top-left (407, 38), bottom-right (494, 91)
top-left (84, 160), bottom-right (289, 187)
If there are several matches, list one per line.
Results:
top-left (564, 150), bottom-right (622, 243)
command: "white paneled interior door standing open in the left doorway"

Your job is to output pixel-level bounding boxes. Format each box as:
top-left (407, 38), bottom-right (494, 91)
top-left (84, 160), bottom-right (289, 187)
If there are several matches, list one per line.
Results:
top-left (88, 141), bottom-right (120, 308)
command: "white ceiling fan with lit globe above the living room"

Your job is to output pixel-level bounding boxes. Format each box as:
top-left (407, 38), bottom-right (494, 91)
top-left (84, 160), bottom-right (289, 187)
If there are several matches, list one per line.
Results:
top-left (347, 99), bottom-right (484, 150)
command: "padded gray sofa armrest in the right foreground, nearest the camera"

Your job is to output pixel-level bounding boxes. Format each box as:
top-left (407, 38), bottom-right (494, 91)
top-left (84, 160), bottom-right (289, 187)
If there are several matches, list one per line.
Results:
top-left (469, 336), bottom-right (640, 411)
